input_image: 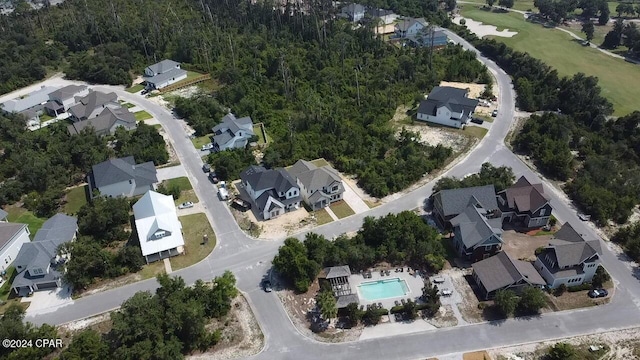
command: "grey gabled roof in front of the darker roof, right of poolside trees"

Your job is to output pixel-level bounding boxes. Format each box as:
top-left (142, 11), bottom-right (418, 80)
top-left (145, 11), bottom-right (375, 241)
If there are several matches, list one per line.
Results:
top-left (451, 204), bottom-right (502, 249)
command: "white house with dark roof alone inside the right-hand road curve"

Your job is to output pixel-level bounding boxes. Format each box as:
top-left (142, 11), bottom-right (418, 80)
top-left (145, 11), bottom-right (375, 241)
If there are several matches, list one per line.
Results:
top-left (417, 86), bottom-right (478, 129)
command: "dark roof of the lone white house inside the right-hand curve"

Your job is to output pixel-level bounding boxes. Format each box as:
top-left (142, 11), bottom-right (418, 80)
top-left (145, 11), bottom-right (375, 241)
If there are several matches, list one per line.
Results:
top-left (418, 86), bottom-right (478, 115)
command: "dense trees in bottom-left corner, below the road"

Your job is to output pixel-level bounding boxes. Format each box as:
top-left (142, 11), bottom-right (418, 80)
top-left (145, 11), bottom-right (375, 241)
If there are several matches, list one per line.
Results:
top-left (0, 271), bottom-right (238, 360)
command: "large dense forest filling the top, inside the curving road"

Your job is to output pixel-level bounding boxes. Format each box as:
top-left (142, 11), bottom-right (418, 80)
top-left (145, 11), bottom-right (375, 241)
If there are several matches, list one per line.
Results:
top-left (0, 0), bottom-right (488, 197)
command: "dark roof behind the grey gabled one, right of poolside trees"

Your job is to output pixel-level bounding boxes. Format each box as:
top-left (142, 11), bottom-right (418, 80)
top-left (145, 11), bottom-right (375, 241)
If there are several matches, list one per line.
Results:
top-left (433, 185), bottom-right (498, 217)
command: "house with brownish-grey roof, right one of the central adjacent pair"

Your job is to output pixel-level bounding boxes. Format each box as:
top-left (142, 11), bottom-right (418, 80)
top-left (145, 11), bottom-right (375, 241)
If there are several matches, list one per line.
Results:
top-left (287, 160), bottom-right (344, 210)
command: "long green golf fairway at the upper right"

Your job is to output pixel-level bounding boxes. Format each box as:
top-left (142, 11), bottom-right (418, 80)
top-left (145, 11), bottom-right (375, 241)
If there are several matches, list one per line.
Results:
top-left (461, 4), bottom-right (640, 115)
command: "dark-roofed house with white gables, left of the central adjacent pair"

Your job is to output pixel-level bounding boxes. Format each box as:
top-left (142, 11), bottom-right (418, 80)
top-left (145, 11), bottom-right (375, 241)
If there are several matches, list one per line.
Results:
top-left (240, 165), bottom-right (300, 220)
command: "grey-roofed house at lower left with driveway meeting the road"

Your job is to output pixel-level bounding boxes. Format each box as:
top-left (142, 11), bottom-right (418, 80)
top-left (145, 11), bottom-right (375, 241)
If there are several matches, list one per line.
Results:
top-left (11, 214), bottom-right (78, 296)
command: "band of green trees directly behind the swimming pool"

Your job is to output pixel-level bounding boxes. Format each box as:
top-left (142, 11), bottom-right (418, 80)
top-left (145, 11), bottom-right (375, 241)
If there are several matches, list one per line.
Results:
top-left (273, 211), bottom-right (446, 292)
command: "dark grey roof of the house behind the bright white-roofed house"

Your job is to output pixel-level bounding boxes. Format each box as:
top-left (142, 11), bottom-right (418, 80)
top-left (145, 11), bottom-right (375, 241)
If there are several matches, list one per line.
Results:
top-left (91, 156), bottom-right (158, 188)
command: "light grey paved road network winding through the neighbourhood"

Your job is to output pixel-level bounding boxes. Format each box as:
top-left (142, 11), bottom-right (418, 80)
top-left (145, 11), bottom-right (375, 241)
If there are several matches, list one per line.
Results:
top-left (22, 31), bottom-right (640, 360)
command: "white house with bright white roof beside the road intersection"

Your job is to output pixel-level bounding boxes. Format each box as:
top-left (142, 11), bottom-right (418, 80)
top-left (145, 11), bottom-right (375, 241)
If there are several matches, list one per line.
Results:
top-left (133, 191), bottom-right (184, 263)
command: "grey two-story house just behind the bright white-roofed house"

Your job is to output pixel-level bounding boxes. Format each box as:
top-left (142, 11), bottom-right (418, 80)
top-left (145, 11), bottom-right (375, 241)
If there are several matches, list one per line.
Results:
top-left (87, 156), bottom-right (158, 198)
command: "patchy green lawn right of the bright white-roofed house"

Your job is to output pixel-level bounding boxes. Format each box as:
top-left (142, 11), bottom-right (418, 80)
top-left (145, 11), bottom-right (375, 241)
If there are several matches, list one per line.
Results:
top-left (171, 213), bottom-right (216, 271)
